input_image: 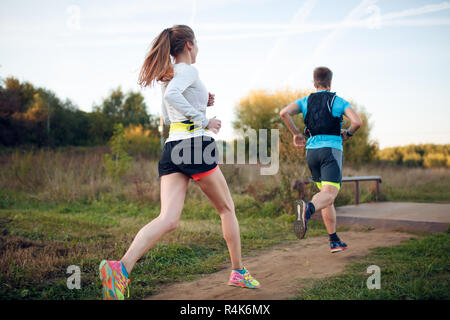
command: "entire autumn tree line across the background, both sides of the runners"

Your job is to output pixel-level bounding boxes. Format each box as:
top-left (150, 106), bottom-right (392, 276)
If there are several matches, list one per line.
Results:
top-left (0, 77), bottom-right (450, 167)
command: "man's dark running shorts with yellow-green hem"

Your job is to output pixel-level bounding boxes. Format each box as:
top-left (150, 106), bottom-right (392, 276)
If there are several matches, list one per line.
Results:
top-left (306, 148), bottom-right (344, 190)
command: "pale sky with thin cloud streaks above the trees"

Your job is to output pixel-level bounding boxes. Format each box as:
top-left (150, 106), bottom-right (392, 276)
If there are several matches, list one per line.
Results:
top-left (0, 0), bottom-right (450, 148)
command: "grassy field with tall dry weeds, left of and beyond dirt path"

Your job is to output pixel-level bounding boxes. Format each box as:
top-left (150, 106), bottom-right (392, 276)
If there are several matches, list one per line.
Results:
top-left (0, 148), bottom-right (450, 299)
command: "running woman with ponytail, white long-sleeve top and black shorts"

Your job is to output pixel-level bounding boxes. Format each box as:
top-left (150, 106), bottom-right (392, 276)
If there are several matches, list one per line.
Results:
top-left (99, 25), bottom-right (260, 300)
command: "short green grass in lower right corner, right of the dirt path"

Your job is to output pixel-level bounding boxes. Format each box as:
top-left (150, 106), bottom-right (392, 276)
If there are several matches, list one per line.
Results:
top-left (294, 232), bottom-right (450, 300)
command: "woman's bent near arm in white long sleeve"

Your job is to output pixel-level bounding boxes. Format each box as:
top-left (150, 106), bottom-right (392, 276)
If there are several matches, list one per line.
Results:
top-left (164, 66), bottom-right (209, 128)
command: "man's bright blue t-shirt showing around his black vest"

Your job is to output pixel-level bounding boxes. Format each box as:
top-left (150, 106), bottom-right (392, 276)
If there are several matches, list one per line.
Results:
top-left (296, 90), bottom-right (352, 151)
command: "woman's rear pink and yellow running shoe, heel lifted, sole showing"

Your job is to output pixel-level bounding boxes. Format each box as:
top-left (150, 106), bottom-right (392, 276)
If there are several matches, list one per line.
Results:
top-left (99, 260), bottom-right (130, 300)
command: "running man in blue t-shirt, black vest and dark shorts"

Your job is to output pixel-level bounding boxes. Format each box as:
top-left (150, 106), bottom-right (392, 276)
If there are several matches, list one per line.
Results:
top-left (280, 67), bottom-right (362, 253)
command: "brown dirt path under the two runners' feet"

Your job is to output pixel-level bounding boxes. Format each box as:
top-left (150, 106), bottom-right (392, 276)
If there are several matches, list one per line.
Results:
top-left (147, 230), bottom-right (414, 300)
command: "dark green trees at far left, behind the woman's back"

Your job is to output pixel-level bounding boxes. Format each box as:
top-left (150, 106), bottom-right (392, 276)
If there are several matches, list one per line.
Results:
top-left (0, 77), bottom-right (159, 147)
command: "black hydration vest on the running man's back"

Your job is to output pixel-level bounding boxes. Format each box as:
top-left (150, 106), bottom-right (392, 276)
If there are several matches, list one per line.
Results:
top-left (305, 91), bottom-right (342, 137)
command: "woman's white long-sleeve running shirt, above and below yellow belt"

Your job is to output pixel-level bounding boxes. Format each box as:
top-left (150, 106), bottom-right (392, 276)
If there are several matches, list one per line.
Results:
top-left (161, 62), bottom-right (211, 142)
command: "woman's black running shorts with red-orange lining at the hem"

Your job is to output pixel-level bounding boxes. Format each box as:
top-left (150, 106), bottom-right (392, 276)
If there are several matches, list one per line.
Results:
top-left (158, 136), bottom-right (218, 180)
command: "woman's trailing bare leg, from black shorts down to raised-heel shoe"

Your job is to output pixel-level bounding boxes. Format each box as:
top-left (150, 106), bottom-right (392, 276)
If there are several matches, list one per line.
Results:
top-left (121, 173), bottom-right (189, 274)
